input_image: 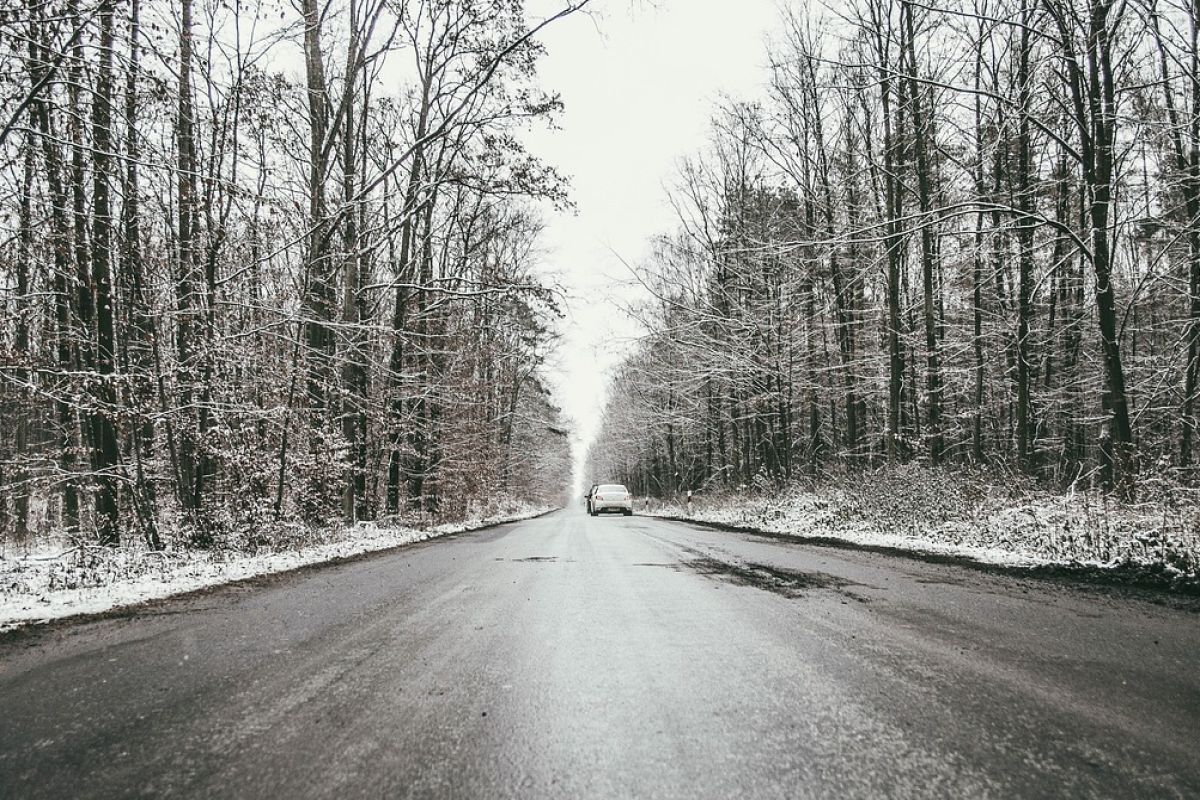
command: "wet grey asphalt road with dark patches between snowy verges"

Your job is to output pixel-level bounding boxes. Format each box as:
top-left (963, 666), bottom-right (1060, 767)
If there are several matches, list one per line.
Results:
top-left (0, 510), bottom-right (1200, 800)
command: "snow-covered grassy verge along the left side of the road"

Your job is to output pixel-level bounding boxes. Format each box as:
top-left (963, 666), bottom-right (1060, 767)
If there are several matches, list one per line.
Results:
top-left (0, 504), bottom-right (551, 631)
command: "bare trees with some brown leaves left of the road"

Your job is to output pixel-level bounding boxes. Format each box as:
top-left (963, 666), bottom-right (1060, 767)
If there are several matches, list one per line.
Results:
top-left (0, 0), bottom-right (586, 548)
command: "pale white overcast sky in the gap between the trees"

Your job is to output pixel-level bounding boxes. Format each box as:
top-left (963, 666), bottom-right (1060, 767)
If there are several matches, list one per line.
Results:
top-left (529, 0), bottom-right (778, 489)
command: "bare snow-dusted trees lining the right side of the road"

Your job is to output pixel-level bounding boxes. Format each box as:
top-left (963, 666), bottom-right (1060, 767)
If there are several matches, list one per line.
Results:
top-left (589, 0), bottom-right (1200, 497)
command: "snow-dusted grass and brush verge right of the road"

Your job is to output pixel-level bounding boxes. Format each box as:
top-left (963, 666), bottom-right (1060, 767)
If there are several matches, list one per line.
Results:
top-left (648, 467), bottom-right (1200, 584)
